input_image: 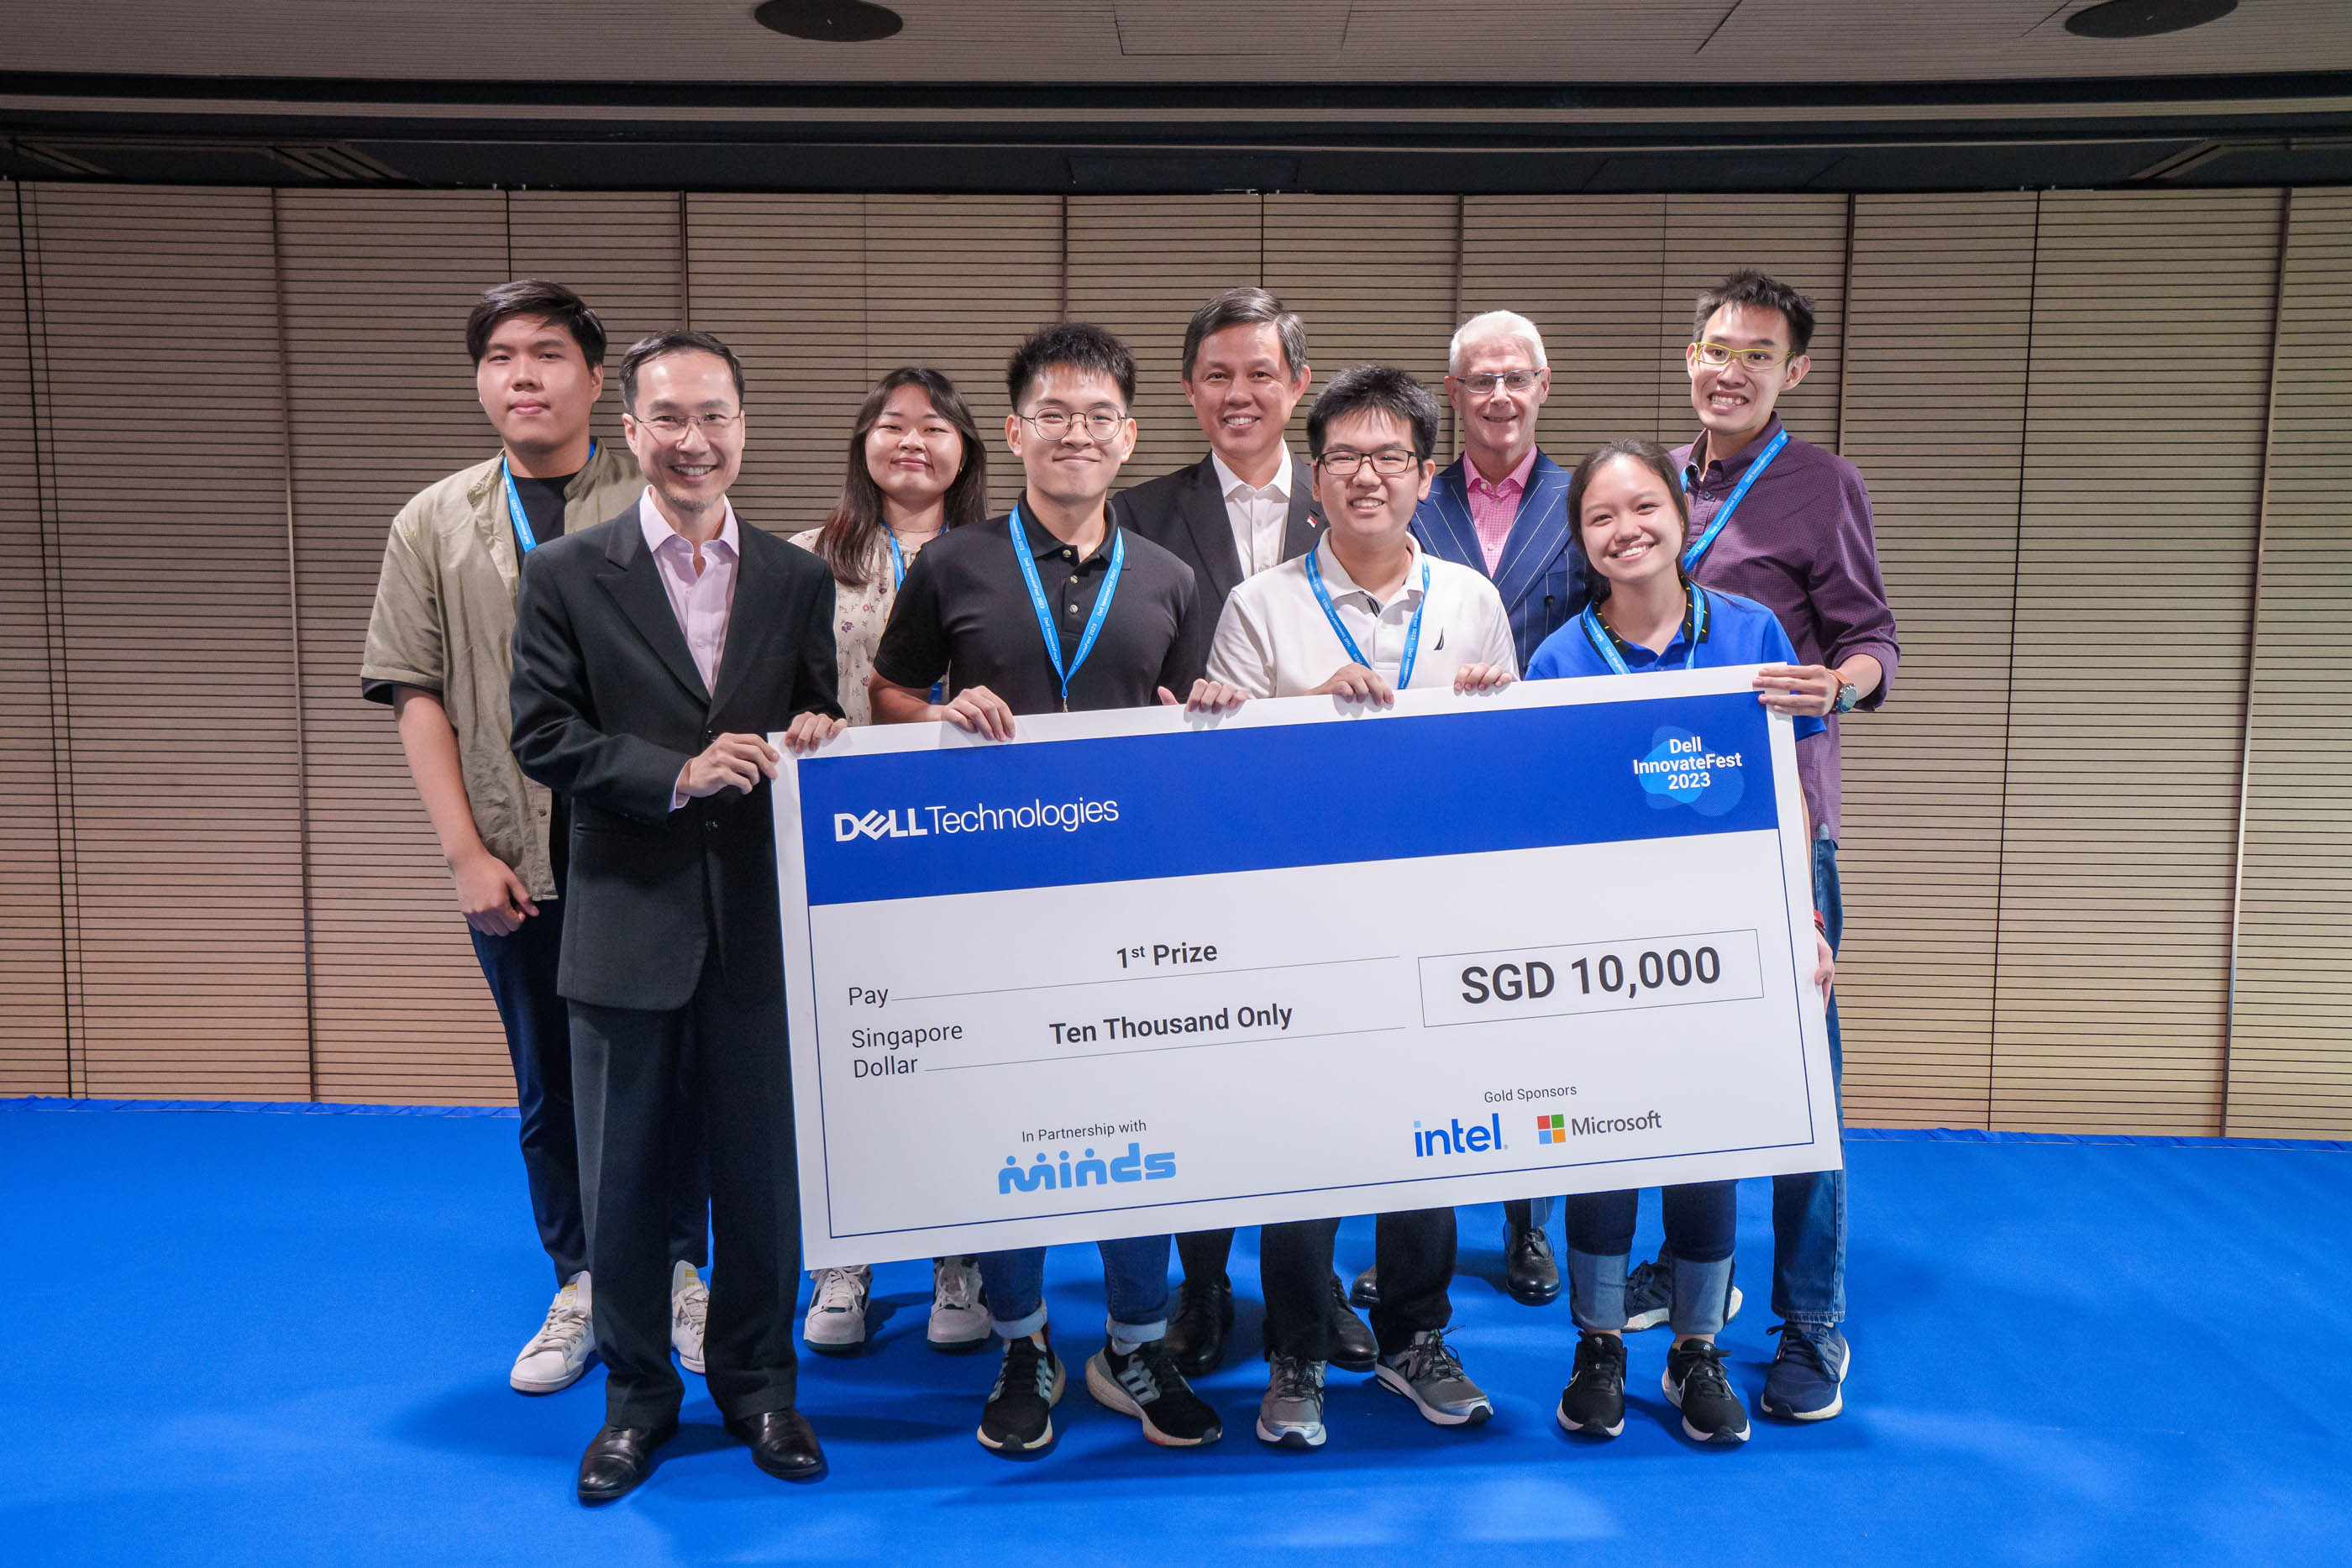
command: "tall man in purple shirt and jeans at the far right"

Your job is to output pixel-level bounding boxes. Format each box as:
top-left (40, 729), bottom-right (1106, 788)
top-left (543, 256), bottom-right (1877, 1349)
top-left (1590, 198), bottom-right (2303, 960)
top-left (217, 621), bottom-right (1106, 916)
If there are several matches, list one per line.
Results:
top-left (1628, 268), bottom-right (1898, 1420)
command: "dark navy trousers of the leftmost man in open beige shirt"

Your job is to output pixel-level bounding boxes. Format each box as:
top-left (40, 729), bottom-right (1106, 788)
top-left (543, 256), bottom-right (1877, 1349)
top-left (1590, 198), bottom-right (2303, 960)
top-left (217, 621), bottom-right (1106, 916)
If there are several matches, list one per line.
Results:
top-left (465, 898), bottom-right (711, 1286)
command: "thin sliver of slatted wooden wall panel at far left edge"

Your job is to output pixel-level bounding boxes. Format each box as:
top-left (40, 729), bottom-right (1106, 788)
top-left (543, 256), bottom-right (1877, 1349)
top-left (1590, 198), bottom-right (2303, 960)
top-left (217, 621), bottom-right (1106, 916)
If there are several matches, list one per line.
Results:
top-left (0, 183), bottom-right (73, 1095)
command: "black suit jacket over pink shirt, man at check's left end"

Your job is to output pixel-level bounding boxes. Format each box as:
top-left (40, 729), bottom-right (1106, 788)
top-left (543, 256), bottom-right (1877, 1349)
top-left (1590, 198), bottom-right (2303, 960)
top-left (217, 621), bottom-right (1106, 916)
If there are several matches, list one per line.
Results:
top-left (508, 506), bottom-right (840, 1011)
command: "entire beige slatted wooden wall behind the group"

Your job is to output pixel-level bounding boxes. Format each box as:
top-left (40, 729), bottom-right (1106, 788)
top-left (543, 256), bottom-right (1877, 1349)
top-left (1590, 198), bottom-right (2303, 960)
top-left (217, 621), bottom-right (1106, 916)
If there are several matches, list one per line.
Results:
top-left (0, 175), bottom-right (2352, 1133)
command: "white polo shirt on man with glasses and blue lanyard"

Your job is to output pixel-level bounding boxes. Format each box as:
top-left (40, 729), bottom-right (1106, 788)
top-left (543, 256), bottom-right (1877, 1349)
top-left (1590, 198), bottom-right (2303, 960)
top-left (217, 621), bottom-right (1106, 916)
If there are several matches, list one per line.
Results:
top-left (1209, 536), bottom-right (1520, 696)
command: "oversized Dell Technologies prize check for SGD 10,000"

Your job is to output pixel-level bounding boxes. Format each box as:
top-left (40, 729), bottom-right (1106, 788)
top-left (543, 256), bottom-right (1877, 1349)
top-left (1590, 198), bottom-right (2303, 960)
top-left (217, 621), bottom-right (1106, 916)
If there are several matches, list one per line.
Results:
top-left (774, 670), bottom-right (1840, 1267)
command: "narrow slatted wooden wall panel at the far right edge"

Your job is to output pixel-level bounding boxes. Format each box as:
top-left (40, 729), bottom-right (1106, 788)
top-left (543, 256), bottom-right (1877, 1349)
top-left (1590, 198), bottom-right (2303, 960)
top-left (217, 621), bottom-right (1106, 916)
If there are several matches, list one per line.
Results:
top-left (2228, 191), bottom-right (2352, 1138)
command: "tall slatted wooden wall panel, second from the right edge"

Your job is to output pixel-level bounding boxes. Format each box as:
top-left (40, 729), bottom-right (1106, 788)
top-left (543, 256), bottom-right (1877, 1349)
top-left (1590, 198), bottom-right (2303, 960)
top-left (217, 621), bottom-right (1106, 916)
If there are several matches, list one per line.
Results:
top-left (1992, 191), bottom-right (2279, 1133)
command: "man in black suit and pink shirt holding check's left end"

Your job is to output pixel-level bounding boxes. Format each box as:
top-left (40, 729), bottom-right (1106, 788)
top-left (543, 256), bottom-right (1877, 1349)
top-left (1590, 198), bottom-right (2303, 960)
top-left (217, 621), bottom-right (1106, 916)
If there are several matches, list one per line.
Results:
top-left (511, 332), bottom-right (842, 1502)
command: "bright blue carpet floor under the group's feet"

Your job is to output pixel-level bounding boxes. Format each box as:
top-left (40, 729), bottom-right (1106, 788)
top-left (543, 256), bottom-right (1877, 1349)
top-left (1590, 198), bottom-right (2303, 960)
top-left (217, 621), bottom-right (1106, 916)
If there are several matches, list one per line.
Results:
top-left (0, 1103), bottom-right (2352, 1568)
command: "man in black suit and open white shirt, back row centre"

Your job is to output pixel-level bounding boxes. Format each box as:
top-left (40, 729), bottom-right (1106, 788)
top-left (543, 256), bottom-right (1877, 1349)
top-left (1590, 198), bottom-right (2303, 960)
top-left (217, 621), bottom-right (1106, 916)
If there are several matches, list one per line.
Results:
top-left (1120, 286), bottom-right (1378, 1377)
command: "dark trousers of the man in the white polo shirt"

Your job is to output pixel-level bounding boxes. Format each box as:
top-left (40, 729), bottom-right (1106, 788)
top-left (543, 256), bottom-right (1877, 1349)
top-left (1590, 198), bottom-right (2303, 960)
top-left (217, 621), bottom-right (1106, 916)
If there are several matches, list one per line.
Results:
top-left (1258, 1209), bottom-right (1453, 1361)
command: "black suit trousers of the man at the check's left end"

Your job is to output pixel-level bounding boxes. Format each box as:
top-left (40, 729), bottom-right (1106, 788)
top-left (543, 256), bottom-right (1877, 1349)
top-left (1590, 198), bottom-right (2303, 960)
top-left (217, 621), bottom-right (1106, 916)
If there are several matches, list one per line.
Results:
top-left (571, 962), bottom-right (800, 1427)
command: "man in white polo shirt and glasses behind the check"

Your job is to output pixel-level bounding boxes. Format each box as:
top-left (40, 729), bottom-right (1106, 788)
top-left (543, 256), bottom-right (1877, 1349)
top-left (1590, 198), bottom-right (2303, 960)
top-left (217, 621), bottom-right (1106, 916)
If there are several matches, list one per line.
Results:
top-left (1188, 364), bottom-right (1520, 1448)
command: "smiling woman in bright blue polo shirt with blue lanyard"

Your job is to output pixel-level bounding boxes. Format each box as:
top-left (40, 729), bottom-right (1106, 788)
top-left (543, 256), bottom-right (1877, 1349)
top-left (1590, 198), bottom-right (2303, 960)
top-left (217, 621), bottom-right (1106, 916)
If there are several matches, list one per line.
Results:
top-left (1526, 439), bottom-right (1830, 1444)
